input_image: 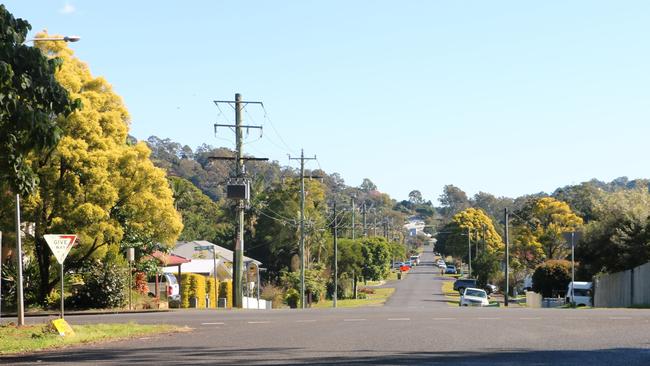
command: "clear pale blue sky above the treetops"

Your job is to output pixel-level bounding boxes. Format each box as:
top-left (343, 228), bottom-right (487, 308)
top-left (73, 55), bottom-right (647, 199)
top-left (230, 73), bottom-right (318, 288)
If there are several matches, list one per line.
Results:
top-left (4, 0), bottom-right (650, 200)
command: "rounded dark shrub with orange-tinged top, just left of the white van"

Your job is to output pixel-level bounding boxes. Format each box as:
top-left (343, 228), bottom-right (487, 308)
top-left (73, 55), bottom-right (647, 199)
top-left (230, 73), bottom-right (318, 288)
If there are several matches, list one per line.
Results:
top-left (533, 260), bottom-right (571, 297)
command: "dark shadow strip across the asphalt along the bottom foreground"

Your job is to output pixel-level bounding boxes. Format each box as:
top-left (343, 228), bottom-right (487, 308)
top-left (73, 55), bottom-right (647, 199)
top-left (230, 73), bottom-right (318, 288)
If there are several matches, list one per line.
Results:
top-left (0, 347), bottom-right (650, 365)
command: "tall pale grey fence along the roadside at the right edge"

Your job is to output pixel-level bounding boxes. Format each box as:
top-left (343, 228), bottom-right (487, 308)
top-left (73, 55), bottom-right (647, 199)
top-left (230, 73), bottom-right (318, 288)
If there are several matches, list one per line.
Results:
top-left (594, 263), bottom-right (650, 308)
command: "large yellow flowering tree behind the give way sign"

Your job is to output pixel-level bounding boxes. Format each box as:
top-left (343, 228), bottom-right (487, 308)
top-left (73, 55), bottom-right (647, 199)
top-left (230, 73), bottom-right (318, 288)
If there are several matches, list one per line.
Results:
top-left (20, 34), bottom-right (182, 301)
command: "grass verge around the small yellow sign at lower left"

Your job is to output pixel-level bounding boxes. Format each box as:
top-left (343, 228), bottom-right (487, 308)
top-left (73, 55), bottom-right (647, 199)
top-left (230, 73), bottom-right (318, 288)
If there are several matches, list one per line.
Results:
top-left (0, 323), bottom-right (189, 354)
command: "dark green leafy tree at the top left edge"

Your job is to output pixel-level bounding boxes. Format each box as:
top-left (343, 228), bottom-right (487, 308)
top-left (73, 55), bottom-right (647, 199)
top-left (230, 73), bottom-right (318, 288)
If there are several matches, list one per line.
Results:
top-left (0, 4), bottom-right (79, 195)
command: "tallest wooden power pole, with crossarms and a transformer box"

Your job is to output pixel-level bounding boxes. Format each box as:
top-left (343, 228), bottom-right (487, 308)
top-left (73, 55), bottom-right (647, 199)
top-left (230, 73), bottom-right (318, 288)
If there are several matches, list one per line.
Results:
top-left (211, 93), bottom-right (268, 308)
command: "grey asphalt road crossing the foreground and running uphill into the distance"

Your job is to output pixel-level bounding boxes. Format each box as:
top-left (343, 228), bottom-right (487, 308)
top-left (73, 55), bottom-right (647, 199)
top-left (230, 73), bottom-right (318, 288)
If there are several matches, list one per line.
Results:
top-left (0, 244), bottom-right (650, 365)
